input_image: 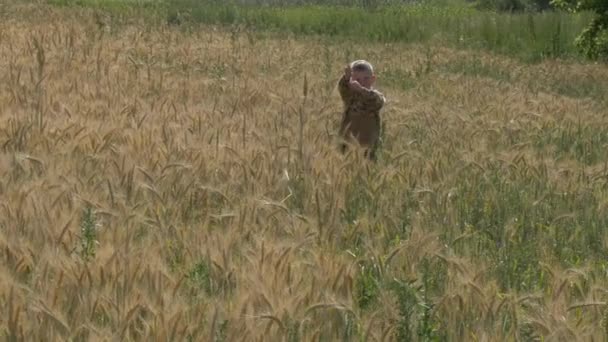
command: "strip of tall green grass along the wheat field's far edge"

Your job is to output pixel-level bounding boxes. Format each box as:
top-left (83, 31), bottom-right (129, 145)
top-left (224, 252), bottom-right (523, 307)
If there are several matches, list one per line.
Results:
top-left (53, 0), bottom-right (592, 61)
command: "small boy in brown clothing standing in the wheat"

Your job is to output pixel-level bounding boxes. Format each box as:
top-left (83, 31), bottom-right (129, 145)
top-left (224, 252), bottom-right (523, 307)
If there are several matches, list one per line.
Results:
top-left (338, 60), bottom-right (386, 161)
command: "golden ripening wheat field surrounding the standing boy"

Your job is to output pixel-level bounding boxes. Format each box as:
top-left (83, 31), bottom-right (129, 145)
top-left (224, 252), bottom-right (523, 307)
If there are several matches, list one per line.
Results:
top-left (0, 4), bottom-right (608, 341)
